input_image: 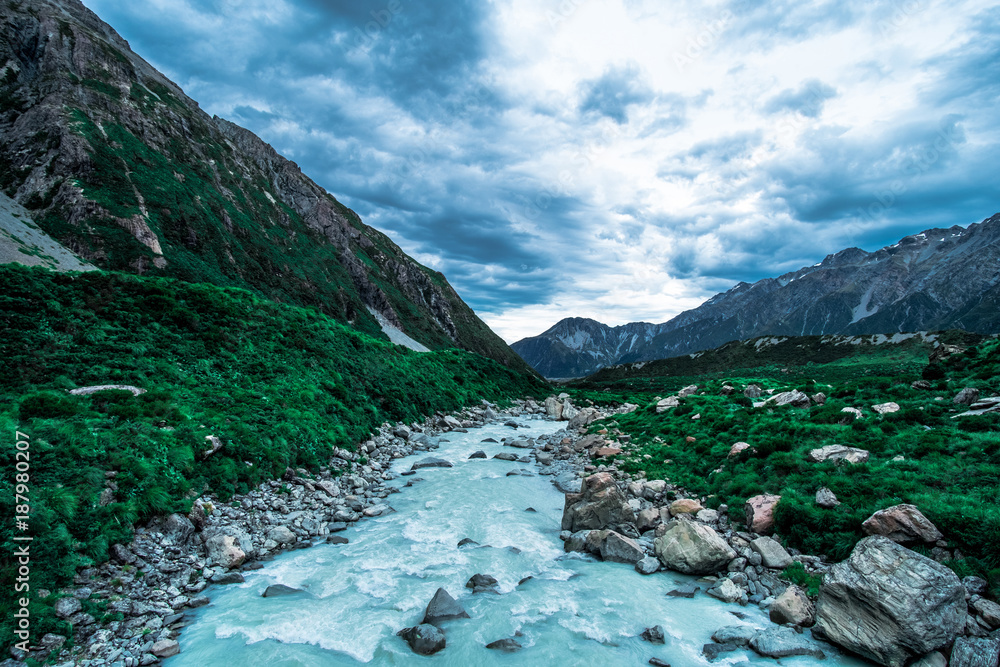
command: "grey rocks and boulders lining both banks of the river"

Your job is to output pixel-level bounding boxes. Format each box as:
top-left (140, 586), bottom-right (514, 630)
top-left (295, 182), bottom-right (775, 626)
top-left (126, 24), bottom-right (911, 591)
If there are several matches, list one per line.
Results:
top-left (9, 397), bottom-right (1000, 667)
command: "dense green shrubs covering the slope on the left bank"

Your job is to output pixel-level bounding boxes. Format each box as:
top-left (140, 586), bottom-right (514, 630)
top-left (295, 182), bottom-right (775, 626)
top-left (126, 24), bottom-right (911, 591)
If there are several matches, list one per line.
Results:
top-left (0, 265), bottom-right (548, 650)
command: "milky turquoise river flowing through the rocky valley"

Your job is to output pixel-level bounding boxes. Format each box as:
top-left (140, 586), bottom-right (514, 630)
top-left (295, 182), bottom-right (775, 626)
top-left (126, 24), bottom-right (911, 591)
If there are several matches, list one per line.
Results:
top-left (165, 419), bottom-right (866, 667)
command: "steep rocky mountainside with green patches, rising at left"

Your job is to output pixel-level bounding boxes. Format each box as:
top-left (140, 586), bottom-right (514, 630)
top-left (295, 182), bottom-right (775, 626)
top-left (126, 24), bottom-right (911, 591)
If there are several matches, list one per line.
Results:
top-left (0, 0), bottom-right (528, 371)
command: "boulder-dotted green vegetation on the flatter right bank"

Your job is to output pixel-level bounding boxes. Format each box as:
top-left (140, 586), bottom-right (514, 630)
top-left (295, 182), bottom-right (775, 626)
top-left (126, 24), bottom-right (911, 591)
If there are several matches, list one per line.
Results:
top-left (577, 339), bottom-right (1000, 596)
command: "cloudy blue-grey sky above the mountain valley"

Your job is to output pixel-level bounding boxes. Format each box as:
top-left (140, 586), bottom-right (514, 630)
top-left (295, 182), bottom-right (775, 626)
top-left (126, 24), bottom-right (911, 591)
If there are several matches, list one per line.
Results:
top-left (84, 0), bottom-right (1000, 342)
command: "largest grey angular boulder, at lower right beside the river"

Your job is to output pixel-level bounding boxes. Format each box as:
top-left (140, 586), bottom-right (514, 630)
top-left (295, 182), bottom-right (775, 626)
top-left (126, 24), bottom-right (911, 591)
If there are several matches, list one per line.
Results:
top-left (816, 536), bottom-right (966, 667)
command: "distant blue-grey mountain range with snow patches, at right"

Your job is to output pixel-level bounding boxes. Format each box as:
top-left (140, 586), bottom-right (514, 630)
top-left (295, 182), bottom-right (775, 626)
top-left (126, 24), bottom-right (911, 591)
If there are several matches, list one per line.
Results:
top-left (511, 214), bottom-right (1000, 378)
